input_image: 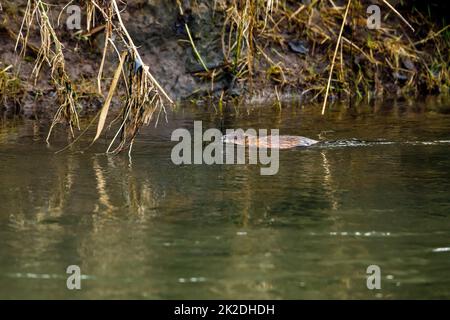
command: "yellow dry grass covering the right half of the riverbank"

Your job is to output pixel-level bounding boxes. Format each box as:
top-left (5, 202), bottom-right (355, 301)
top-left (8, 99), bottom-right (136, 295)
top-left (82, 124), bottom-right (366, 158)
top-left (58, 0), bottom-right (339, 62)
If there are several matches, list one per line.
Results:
top-left (213, 0), bottom-right (450, 105)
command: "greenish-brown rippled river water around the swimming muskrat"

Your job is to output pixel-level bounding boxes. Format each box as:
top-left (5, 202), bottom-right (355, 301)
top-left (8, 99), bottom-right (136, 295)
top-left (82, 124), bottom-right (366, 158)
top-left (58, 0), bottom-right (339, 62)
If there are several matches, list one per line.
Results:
top-left (0, 99), bottom-right (450, 299)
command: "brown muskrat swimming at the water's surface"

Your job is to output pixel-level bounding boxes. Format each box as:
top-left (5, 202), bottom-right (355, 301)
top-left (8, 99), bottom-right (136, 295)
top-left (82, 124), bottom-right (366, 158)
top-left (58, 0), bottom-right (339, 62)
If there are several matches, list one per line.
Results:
top-left (222, 131), bottom-right (319, 149)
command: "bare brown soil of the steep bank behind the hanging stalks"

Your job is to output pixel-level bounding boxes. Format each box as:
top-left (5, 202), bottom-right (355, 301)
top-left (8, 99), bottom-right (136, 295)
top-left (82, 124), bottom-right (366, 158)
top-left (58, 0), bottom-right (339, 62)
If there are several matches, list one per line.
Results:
top-left (0, 0), bottom-right (448, 114)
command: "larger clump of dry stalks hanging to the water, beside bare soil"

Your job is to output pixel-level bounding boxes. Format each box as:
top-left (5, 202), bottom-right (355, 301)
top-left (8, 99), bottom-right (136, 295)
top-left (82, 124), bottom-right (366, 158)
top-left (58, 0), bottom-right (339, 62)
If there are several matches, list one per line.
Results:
top-left (91, 0), bottom-right (173, 153)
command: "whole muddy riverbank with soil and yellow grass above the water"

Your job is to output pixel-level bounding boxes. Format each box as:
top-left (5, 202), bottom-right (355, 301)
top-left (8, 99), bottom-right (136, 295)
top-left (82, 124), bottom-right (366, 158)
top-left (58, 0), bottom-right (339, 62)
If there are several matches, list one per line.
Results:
top-left (0, 0), bottom-right (450, 118)
